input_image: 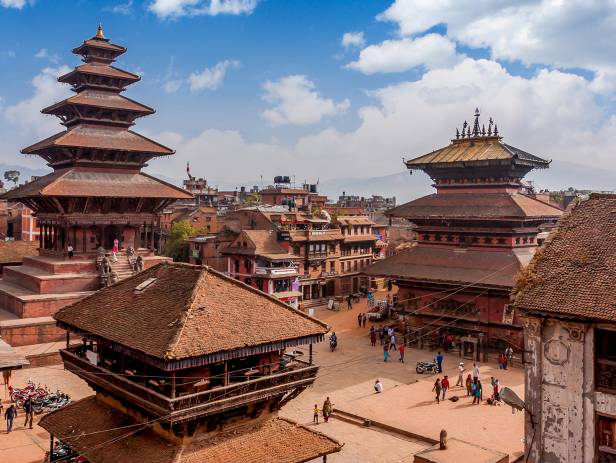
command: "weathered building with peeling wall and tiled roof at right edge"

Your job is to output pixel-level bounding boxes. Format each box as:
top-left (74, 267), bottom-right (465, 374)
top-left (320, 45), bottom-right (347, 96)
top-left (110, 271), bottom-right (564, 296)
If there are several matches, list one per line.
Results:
top-left (513, 194), bottom-right (616, 463)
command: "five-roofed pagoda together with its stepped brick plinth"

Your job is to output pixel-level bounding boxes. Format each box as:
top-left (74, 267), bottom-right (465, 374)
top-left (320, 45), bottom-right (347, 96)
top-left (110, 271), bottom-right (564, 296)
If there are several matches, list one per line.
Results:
top-left (0, 26), bottom-right (192, 354)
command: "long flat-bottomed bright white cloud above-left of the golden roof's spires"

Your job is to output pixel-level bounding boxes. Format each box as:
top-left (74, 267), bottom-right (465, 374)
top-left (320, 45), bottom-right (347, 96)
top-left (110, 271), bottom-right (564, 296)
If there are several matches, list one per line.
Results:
top-left (347, 34), bottom-right (460, 74)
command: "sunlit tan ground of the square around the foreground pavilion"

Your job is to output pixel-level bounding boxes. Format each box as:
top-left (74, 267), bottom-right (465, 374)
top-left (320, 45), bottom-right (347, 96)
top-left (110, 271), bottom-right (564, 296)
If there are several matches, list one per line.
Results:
top-left (0, 292), bottom-right (524, 463)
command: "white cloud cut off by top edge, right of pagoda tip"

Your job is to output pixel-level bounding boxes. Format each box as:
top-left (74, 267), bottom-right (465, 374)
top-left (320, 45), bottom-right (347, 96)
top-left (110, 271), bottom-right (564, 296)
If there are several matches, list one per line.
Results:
top-left (148, 0), bottom-right (257, 19)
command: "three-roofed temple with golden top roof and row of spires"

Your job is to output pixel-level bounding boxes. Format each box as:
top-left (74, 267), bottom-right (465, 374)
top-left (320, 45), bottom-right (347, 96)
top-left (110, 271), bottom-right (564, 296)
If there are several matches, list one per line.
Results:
top-left (366, 110), bottom-right (562, 357)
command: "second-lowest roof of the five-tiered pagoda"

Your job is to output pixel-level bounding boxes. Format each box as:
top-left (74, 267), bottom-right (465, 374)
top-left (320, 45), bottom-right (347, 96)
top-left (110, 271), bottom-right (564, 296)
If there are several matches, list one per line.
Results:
top-left (21, 124), bottom-right (174, 156)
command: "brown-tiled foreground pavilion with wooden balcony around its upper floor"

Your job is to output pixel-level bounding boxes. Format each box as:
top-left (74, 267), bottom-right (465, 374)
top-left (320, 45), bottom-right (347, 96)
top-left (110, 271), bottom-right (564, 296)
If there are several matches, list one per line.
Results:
top-left (40, 262), bottom-right (341, 463)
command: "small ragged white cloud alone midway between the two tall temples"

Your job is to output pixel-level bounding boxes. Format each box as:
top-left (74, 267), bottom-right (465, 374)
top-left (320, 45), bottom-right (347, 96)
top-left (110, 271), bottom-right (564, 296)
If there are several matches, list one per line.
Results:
top-left (261, 75), bottom-right (351, 125)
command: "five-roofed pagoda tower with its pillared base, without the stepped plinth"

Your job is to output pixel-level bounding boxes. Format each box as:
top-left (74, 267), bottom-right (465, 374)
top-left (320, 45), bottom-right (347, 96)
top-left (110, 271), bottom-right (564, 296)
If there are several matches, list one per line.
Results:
top-left (6, 26), bottom-right (192, 255)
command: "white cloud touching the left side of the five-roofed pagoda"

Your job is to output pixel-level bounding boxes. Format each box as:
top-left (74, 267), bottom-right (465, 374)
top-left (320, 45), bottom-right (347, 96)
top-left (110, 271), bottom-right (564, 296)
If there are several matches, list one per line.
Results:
top-left (3, 66), bottom-right (70, 136)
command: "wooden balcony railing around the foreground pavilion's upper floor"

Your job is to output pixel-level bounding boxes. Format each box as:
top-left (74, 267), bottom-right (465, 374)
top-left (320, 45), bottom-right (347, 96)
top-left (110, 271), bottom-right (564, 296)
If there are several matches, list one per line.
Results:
top-left (60, 349), bottom-right (319, 422)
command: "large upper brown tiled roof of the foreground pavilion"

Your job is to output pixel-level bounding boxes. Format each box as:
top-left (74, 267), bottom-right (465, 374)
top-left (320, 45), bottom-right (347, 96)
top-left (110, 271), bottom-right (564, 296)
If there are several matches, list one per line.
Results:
top-left (54, 263), bottom-right (328, 361)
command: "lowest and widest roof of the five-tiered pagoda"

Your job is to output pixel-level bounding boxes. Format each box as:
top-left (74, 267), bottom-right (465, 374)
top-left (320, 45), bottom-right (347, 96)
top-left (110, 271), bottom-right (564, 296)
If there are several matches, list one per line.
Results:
top-left (3, 167), bottom-right (192, 199)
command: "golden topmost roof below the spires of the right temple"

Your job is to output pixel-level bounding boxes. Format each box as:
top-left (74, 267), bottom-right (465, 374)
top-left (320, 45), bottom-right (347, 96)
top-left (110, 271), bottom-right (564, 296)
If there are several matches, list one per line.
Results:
top-left (406, 137), bottom-right (550, 169)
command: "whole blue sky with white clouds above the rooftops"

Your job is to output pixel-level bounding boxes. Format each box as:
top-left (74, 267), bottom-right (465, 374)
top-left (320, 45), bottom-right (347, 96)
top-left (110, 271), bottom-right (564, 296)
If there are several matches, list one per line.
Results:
top-left (0, 0), bottom-right (616, 193)
